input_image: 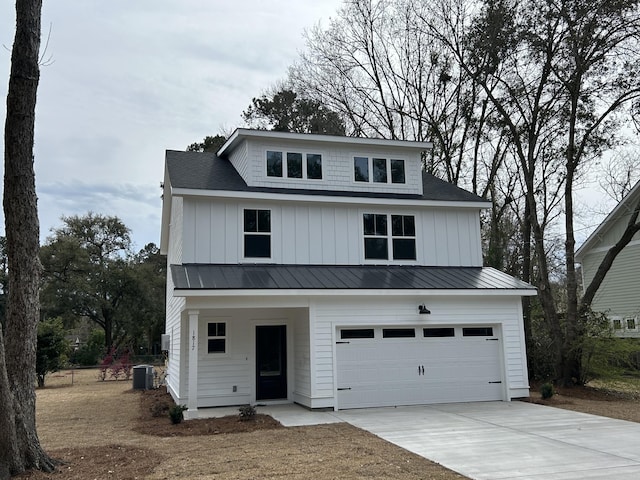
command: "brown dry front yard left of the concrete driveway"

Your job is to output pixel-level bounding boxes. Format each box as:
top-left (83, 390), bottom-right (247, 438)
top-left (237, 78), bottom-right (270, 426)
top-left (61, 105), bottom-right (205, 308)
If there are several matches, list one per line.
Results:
top-left (17, 371), bottom-right (465, 480)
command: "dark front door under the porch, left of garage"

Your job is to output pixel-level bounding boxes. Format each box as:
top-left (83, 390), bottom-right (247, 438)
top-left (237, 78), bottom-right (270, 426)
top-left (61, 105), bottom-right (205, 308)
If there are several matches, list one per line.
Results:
top-left (256, 325), bottom-right (287, 400)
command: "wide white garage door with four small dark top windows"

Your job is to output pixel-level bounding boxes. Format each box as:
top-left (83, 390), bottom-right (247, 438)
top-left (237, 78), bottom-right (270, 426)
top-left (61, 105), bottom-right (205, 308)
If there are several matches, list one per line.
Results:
top-left (336, 326), bottom-right (504, 409)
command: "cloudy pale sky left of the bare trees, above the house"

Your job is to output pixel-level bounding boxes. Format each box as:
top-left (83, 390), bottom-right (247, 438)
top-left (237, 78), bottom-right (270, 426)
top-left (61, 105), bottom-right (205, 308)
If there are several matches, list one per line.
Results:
top-left (0, 0), bottom-right (341, 250)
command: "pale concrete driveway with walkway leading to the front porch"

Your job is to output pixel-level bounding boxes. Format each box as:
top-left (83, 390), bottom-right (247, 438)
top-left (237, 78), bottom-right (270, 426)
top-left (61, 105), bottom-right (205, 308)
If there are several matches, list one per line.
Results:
top-left (252, 402), bottom-right (640, 480)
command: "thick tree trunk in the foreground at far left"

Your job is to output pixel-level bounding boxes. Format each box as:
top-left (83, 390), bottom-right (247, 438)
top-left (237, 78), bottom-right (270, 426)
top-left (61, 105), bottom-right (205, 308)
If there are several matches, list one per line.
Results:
top-left (0, 0), bottom-right (53, 474)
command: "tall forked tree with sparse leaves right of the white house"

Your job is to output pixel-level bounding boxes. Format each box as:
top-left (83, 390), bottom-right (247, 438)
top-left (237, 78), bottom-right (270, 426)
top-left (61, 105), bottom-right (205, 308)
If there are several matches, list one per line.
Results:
top-left (425, 0), bottom-right (640, 383)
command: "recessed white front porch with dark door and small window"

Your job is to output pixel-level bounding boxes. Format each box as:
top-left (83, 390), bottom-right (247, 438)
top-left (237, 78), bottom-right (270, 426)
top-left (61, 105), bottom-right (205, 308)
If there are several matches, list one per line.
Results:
top-left (168, 307), bottom-right (311, 418)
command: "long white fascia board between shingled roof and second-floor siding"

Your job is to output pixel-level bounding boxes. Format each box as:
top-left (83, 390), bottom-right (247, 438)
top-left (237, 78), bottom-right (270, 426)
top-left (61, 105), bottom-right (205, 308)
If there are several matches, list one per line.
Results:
top-left (173, 188), bottom-right (491, 209)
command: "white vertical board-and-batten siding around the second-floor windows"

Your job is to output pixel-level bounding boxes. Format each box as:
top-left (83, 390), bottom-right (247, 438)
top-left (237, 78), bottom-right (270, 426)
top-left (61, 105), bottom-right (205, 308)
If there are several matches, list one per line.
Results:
top-left (182, 198), bottom-right (482, 266)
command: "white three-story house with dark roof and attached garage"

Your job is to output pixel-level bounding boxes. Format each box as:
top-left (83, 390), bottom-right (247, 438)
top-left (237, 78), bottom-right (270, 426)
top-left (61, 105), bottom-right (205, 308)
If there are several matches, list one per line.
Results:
top-left (161, 129), bottom-right (535, 415)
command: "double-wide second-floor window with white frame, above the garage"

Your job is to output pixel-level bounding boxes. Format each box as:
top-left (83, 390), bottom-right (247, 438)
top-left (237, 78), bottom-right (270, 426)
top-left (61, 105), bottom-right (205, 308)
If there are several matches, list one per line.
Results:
top-left (362, 213), bottom-right (417, 260)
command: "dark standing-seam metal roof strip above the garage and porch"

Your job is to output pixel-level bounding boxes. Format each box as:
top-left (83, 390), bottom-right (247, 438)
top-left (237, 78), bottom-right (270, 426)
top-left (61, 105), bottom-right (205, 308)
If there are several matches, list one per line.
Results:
top-left (171, 264), bottom-right (535, 290)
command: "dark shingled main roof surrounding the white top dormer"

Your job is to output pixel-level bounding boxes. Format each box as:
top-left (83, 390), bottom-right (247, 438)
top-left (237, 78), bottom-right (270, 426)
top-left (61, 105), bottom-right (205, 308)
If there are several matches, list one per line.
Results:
top-left (166, 150), bottom-right (487, 202)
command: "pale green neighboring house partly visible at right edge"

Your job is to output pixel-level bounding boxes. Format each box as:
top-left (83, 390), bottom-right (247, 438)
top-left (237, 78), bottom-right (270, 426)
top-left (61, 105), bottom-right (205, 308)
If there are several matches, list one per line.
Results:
top-left (576, 182), bottom-right (640, 337)
